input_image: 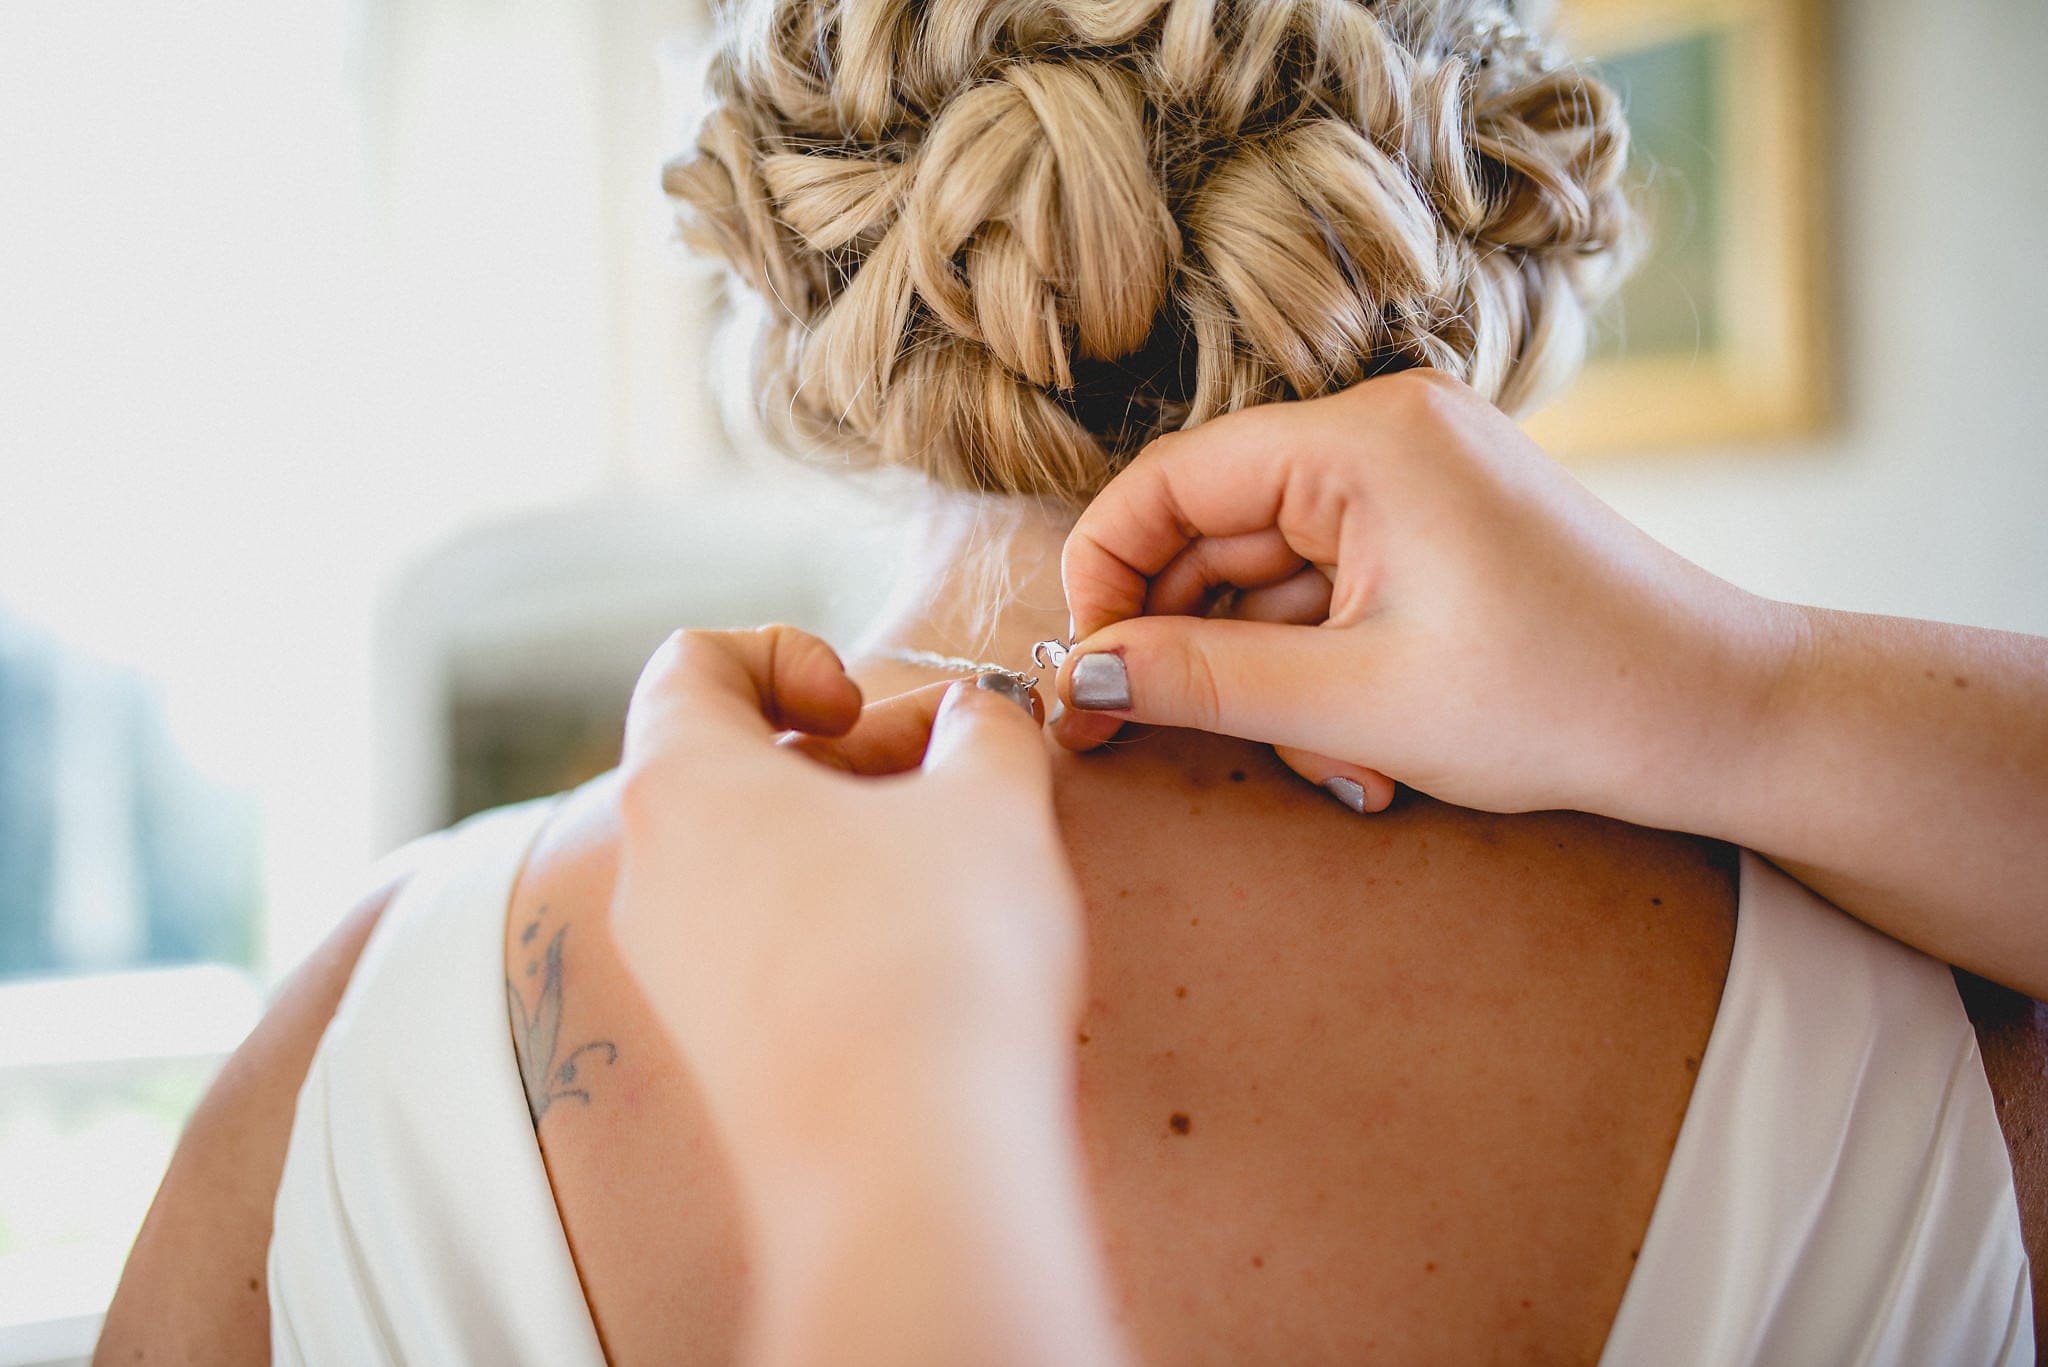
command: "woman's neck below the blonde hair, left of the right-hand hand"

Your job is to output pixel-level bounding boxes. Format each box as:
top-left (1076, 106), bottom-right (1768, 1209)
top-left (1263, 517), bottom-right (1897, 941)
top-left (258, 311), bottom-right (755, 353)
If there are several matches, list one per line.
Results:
top-left (848, 494), bottom-right (1073, 687)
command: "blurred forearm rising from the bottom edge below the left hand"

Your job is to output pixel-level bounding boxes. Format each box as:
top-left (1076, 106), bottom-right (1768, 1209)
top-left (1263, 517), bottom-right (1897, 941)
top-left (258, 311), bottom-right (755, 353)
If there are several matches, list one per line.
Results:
top-left (750, 1078), bottom-right (1126, 1367)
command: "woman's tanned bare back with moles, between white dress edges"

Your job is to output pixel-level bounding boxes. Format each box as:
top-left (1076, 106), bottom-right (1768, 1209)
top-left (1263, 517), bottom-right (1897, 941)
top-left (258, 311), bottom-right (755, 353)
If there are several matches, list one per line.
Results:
top-left (506, 732), bottom-right (1735, 1361)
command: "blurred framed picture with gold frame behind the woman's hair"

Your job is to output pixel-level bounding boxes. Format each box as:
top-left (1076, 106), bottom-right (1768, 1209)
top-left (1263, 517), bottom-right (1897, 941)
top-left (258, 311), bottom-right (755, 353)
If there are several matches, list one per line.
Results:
top-left (1528, 0), bottom-right (1831, 455)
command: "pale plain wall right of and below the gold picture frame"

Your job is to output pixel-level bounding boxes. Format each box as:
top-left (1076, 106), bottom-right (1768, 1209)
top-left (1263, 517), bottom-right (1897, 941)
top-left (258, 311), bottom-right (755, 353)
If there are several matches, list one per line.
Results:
top-left (1579, 0), bottom-right (2048, 635)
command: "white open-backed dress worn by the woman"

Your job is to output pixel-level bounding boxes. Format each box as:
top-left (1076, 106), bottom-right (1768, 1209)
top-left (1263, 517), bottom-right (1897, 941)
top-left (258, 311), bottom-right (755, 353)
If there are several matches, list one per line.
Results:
top-left (270, 801), bottom-right (2034, 1367)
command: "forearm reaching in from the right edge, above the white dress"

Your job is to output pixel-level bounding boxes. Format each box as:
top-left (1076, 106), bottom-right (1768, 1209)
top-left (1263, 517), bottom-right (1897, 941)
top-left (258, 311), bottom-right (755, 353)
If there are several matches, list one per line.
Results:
top-left (1669, 609), bottom-right (2048, 996)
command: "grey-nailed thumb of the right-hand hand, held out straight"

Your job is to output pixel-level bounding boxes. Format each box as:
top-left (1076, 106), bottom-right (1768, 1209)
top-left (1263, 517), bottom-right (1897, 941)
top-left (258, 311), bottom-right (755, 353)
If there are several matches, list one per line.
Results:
top-left (1059, 617), bottom-right (1366, 754)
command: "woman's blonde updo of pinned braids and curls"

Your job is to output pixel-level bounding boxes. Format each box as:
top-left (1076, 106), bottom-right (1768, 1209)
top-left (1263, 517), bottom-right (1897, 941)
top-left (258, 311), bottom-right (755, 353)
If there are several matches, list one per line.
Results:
top-left (664, 0), bottom-right (1634, 504)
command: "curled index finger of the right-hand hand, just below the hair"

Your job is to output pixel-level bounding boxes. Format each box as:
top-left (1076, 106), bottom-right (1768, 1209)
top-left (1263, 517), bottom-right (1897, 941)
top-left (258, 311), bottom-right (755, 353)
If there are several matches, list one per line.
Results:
top-left (1059, 389), bottom-right (1337, 639)
